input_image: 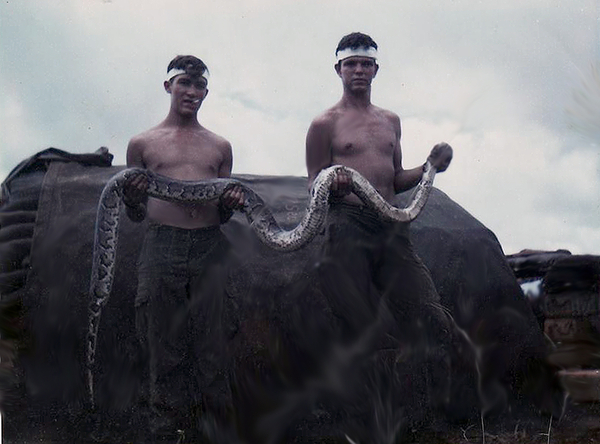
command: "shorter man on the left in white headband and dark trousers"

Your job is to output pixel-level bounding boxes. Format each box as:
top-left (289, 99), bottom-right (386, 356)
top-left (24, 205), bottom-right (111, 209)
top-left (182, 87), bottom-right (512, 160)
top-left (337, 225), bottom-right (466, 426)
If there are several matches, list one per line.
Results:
top-left (124, 56), bottom-right (244, 442)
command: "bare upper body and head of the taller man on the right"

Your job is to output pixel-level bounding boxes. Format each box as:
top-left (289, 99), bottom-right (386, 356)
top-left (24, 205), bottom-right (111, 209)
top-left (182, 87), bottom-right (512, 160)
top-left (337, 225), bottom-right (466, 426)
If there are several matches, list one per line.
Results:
top-left (306, 33), bottom-right (452, 202)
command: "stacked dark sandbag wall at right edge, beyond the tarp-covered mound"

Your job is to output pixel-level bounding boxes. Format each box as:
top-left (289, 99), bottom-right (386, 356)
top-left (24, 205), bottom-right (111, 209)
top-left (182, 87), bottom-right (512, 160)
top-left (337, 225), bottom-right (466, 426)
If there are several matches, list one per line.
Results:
top-left (507, 250), bottom-right (600, 402)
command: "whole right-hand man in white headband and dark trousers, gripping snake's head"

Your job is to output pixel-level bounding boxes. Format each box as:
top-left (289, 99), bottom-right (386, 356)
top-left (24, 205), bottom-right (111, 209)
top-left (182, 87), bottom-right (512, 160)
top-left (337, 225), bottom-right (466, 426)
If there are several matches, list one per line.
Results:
top-left (306, 33), bottom-right (452, 426)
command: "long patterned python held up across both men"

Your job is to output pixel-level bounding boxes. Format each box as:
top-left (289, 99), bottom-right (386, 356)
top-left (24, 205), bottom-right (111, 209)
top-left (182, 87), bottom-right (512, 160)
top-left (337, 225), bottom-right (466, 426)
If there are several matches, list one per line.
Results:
top-left (87, 162), bottom-right (436, 406)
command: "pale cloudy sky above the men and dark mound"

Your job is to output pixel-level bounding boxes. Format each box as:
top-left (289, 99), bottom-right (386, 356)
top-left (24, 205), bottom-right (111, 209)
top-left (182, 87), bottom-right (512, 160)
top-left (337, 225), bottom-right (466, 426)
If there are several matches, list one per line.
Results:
top-left (0, 0), bottom-right (600, 254)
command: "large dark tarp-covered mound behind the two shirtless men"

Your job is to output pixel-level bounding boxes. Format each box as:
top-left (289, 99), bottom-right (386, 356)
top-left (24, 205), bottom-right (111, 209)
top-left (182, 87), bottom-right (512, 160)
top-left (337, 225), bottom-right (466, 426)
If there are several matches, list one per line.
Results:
top-left (0, 150), bottom-right (597, 444)
